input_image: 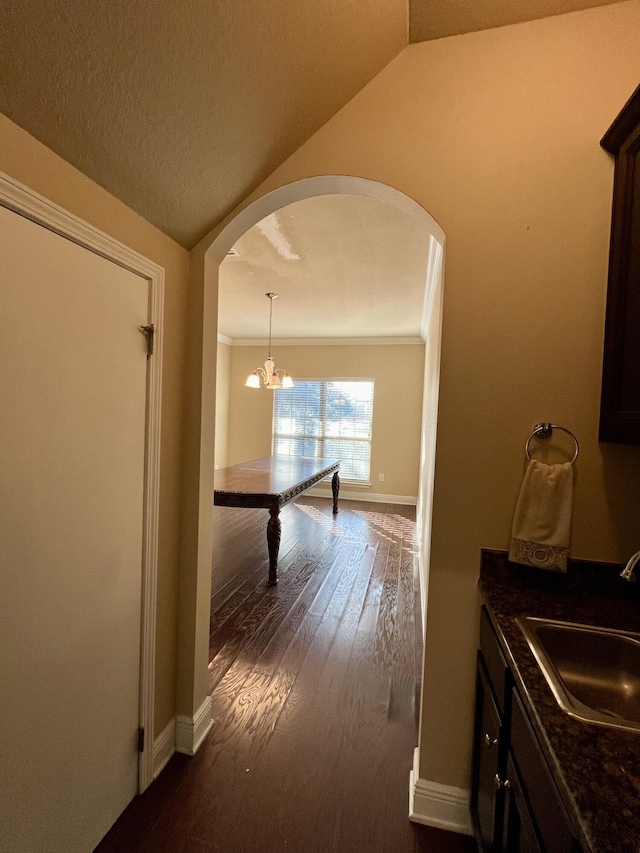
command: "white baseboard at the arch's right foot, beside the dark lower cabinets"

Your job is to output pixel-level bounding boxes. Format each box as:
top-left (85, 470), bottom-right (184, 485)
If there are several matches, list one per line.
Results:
top-left (409, 748), bottom-right (473, 835)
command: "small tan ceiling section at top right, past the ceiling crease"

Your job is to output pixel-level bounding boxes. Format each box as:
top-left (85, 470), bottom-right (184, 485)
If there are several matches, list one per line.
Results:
top-left (409, 0), bottom-right (619, 42)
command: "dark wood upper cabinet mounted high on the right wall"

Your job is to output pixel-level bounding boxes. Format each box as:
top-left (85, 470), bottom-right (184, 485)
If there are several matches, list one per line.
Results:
top-left (600, 86), bottom-right (640, 444)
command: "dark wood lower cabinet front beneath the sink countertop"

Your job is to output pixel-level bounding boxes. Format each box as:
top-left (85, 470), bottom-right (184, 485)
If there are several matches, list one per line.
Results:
top-left (471, 608), bottom-right (581, 853)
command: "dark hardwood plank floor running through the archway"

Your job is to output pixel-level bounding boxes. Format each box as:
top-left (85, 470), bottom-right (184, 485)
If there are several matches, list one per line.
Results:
top-left (97, 497), bottom-right (475, 853)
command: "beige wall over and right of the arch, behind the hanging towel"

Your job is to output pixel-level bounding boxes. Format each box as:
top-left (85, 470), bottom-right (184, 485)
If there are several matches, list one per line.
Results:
top-left (198, 0), bottom-right (640, 787)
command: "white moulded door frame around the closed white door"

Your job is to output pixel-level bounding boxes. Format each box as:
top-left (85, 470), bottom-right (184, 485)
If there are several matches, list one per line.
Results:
top-left (0, 172), bottom-right (164, 793)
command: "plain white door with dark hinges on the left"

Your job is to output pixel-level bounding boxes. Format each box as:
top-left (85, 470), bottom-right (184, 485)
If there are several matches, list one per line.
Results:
top-left (0, 207), bottom-right (149, 853)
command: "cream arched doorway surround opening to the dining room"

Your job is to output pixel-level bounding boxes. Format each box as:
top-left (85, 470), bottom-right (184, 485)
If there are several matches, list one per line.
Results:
top-left (177, 175), bottom-right (445, 752)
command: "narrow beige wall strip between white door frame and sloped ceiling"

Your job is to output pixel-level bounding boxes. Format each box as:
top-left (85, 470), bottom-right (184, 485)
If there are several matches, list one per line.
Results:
top-left (0, 115), bottom-right (189, 733)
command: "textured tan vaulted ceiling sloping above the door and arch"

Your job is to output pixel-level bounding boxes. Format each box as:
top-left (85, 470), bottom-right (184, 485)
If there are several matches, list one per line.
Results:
top-left (0, 0), bottom-right (613, 248)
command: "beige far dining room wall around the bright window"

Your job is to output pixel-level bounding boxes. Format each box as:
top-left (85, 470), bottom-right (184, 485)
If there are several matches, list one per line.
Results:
top-left (229, 344), bottom-right (424, 497)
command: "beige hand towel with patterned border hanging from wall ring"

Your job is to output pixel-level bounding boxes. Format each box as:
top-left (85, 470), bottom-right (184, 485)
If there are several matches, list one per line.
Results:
top-left (509, 459), bottom-right (573, 572)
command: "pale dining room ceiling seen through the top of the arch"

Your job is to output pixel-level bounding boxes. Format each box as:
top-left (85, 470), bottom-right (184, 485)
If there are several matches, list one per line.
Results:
top-left (219, 195), bottom-right (429, 338)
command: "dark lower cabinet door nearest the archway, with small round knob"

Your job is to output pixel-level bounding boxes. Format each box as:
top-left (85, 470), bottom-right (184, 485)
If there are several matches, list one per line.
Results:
top-left (471, 652), bottom-right (504, 853)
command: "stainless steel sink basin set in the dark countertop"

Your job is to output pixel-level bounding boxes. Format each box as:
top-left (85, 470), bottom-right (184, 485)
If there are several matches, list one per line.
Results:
top-left (516, 616), bottom-right (640, 730)
